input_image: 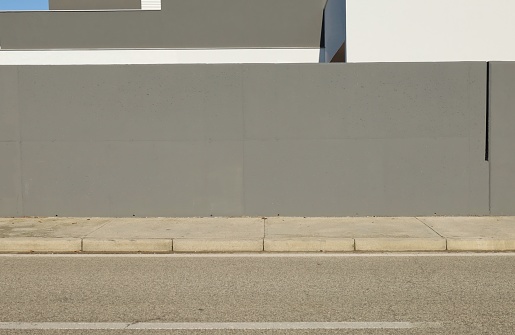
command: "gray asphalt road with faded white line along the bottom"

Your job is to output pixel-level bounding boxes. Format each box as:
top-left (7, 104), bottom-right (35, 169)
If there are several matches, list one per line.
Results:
top-left (0, 254), bottom-right (515, 335)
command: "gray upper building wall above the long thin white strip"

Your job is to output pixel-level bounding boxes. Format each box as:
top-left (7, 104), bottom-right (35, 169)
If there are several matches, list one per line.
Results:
top-left (0, 0), bottom-right (326, 49)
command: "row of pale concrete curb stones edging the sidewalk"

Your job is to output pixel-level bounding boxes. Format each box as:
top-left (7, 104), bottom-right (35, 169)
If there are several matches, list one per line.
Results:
top-left (0, 237), bottom-right (515, 253)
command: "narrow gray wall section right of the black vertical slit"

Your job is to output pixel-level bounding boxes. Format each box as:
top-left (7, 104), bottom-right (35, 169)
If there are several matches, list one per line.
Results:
top-left (489, 62), bottom-right (515, 215)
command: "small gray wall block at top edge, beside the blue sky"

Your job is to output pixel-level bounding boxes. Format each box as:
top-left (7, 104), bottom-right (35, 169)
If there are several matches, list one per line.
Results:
top-left (48, 0), bottom-right (141, 10)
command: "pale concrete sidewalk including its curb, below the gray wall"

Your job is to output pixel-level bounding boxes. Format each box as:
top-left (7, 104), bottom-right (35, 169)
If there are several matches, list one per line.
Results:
top-left (0, 217), bottom-right (515, 253)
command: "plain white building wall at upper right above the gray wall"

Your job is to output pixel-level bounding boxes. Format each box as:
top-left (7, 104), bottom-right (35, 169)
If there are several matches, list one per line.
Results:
top-left (347, 0), bottom-right (515, 62)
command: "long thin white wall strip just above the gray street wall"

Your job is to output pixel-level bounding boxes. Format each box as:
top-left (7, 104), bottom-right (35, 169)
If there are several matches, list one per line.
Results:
top-left (0, 48), bottom-right (320, 65)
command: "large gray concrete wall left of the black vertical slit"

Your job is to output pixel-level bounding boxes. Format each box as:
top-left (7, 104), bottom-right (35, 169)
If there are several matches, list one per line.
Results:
top-left (0, 63), bottom-right (489, 216)
